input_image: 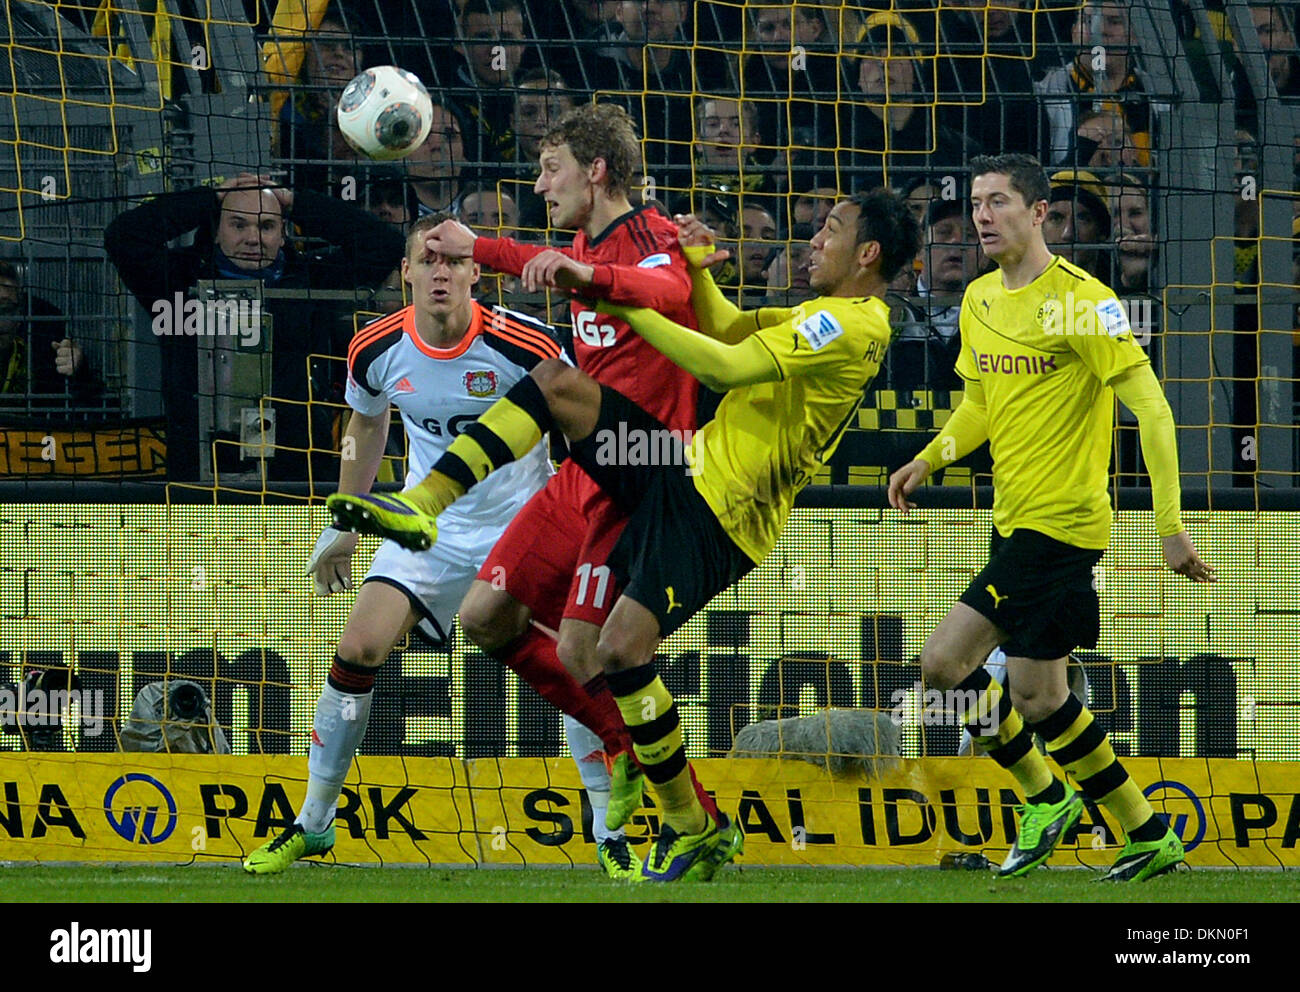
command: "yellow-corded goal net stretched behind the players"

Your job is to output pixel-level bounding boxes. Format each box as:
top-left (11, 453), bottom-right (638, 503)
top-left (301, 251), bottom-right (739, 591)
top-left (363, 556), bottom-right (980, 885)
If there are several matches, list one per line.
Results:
top-left (0, 0), bottom-right (1300, 867)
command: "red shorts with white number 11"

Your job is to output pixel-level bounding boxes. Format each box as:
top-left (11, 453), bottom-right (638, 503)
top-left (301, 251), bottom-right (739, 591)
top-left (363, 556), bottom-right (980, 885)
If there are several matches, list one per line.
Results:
top-left (478, 459), bottom-right (628, 629)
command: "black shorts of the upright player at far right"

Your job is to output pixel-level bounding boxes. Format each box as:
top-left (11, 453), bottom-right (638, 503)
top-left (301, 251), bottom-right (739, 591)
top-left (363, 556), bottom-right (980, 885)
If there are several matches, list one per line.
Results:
top-left (961, 529), bottom-right (1104, 659)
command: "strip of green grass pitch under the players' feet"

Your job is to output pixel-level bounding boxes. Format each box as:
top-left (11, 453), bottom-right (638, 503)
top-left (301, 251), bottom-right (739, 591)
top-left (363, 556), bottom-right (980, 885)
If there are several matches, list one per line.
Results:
top-left (0, 863), bottom-right (1300, 904)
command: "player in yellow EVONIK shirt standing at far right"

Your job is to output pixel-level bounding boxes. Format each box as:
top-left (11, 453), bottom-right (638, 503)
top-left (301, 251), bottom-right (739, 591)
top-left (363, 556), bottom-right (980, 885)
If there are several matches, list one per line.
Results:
top-left (889, 155), bottom-right (1214, 881)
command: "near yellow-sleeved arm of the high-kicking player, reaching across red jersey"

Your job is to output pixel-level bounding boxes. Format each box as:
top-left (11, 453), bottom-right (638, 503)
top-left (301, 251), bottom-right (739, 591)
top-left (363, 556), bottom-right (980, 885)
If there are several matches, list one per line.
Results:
top-left (593, 300), bottom-right (781, 393)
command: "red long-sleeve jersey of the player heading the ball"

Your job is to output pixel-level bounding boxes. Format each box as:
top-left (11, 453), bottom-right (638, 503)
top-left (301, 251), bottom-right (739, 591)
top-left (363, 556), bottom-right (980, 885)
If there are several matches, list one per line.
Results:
top-left (475, 207), bottom-right (699, 430)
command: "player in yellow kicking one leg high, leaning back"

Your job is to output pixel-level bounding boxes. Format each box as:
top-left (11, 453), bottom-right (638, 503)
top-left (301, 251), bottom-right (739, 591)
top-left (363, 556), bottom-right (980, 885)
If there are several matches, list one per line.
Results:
top-left (329, 190), bottom-right (919, 881)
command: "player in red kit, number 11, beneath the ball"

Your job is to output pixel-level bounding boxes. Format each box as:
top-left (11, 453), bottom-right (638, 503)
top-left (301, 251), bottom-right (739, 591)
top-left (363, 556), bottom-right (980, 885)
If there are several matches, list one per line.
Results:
top-left (366, 104), bottom-right (744, 865)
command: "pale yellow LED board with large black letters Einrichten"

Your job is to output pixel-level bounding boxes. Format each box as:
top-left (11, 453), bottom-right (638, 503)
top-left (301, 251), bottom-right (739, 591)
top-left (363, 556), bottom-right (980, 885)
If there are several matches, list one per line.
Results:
top-left (0, 504), bottom-right (1300, 761)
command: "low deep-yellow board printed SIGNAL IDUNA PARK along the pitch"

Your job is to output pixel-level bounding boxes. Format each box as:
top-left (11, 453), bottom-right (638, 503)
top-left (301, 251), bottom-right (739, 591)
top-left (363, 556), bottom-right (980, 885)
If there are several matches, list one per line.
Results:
top-left (0, 754), bottom-right (1300, 868)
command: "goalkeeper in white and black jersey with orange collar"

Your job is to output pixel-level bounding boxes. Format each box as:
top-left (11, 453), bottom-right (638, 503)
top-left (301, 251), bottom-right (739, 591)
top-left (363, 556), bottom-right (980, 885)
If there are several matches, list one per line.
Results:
top-left (244, 215), bottom-right (633, 875)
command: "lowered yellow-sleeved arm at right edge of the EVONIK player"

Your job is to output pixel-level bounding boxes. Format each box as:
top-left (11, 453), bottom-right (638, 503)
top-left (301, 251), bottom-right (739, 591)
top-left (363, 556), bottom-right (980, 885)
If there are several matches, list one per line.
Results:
top-left (1110, 363), bottom-right (1214, 582)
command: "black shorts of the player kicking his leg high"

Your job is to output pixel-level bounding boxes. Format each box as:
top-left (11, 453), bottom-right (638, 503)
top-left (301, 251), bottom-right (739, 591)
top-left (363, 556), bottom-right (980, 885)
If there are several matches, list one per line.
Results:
top-left (571, 386), bottom-right (754, 637)
